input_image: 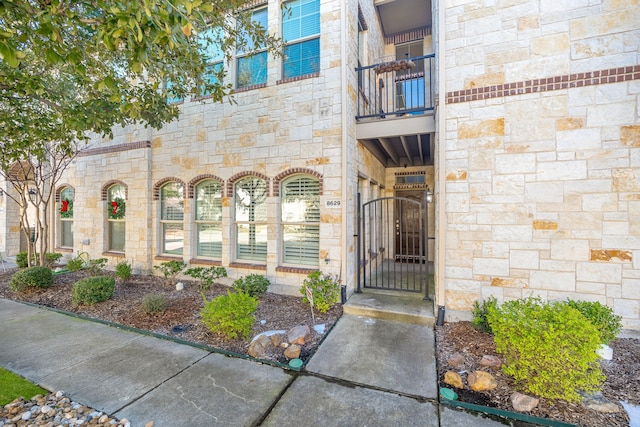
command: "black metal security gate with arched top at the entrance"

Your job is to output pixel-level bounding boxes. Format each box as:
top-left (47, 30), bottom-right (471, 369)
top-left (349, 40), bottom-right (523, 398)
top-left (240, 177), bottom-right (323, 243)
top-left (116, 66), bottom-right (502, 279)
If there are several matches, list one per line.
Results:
top-left (356, 194), bottom-right (429, 299)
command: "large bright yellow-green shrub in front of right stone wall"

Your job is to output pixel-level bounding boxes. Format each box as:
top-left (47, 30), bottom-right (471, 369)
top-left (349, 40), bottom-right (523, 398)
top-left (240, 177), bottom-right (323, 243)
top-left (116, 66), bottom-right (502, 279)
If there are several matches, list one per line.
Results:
top-left (487, 298), bottom-right (604, 402)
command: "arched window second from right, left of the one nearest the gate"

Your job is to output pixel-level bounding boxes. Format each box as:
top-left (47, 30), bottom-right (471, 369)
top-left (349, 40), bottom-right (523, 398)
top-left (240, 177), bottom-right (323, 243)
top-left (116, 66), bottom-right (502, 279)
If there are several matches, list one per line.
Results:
top-left (234, 177), bottom-right (267, 262)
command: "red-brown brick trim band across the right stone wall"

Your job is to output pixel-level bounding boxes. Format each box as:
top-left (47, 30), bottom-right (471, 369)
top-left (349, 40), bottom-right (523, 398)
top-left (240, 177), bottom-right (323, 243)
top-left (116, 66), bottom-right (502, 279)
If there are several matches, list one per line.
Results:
top-left (446, 65), bottom-right (640, 104)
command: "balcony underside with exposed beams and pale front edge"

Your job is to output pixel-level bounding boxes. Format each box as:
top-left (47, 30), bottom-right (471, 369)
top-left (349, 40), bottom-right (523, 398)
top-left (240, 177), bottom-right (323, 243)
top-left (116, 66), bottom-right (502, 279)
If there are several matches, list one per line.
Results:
top-left (356, 114), bottom-right (435, 167)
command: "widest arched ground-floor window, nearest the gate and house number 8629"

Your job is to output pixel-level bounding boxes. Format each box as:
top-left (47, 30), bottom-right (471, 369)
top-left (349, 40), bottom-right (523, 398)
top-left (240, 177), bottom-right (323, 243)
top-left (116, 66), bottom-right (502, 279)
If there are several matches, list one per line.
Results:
top-left (280, 175), bottom-right (320, 267)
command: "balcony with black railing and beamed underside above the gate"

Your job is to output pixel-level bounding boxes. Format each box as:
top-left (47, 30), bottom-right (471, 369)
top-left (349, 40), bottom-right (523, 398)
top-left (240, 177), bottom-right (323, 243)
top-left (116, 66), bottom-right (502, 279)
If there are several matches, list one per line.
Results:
top-left (356, 55), bottom-right (435, 167)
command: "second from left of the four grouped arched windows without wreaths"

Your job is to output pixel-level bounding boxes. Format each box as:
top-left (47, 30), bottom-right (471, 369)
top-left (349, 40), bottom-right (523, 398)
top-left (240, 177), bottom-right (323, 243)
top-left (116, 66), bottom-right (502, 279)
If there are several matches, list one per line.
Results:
top-left (195, 179), bottom-right (222, 258)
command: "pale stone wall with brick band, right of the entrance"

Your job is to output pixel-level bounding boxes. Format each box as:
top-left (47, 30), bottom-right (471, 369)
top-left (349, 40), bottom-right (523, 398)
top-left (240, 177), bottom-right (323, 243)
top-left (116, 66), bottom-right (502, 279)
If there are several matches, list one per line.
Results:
top-left (440, 0), bottom-right (640, 329)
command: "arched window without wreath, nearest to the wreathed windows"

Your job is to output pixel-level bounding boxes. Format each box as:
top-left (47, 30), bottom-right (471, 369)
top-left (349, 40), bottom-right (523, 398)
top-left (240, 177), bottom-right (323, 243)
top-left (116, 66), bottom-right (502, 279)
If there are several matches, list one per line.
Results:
top-left (160, 182), bottom-right (184, 255)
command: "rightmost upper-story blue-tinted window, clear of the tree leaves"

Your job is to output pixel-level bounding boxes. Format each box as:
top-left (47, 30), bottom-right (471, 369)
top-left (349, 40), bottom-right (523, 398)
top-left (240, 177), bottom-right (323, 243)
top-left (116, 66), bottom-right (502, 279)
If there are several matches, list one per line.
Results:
top-left (282, 0), bottom-right (320, 79)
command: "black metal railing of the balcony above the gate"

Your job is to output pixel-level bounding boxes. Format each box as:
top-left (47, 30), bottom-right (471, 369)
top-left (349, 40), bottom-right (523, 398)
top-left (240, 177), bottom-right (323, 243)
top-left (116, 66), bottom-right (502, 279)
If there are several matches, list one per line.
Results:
top-left (356, 54), bottom-right (435, 119)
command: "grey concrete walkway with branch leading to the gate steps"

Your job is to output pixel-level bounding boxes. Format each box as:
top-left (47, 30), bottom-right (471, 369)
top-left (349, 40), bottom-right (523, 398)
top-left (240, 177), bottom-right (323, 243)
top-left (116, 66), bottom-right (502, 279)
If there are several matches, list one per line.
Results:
top-left (0, 299), bottom-right (524, 427)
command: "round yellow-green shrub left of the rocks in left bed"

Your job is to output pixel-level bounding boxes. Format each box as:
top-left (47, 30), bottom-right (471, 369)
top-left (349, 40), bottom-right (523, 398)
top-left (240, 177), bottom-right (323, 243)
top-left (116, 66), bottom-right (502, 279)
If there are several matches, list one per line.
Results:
top-left (200, 291), bottom-right (258, 339)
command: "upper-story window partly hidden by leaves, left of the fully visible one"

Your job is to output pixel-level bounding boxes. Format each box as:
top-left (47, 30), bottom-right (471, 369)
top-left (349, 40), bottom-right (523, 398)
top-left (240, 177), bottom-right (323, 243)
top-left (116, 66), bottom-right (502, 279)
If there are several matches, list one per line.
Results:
top-left (236, 7), bottom-right (269, 88)
